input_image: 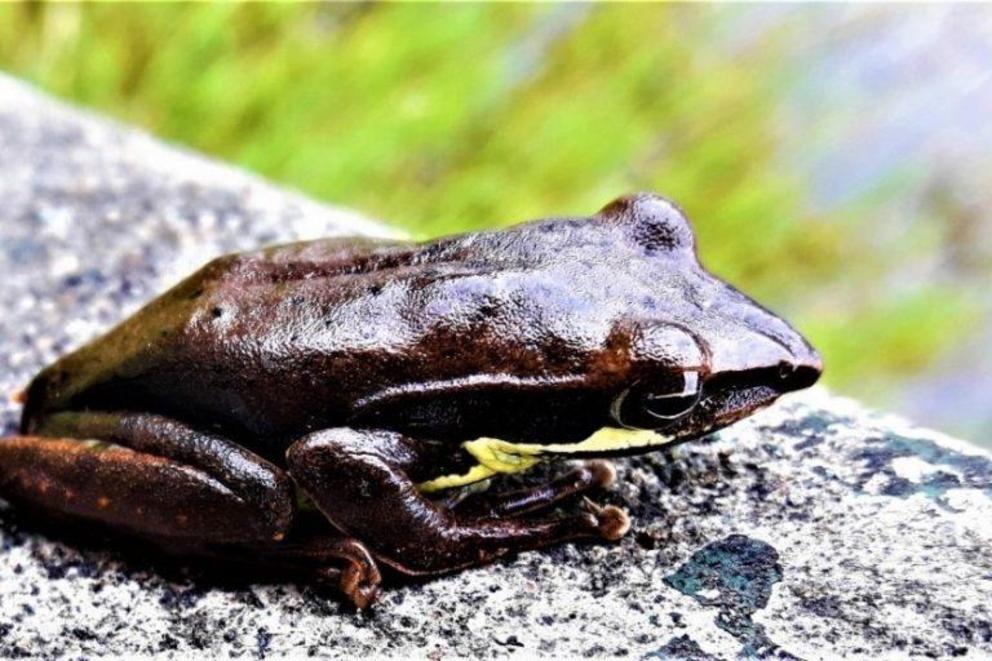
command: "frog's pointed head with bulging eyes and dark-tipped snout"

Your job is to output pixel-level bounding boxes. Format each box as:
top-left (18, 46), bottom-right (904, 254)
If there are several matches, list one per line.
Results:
top-left (600, 194), bottom-right (822, 440)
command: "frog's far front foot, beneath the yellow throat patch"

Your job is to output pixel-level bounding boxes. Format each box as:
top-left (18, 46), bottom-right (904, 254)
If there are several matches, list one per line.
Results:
top-left (450, 459), bottom-right (617, 517)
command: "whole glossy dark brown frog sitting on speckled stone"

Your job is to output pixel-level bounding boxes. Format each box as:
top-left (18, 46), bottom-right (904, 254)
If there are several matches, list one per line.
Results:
top-left (0, 194), bottom-right (821, 607)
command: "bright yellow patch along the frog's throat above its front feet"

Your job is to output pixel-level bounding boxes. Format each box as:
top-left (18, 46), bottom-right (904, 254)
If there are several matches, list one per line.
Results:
top-left (418, 427), bottom-right (673, 493)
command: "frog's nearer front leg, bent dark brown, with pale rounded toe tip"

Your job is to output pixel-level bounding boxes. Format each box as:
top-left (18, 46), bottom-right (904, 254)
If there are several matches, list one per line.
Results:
top-left (286, 428), bottom-right (628, 574)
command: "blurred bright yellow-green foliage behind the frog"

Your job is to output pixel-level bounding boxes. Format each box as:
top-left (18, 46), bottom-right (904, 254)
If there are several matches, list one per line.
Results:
top-left (0, 3), bottom-right (970, 408)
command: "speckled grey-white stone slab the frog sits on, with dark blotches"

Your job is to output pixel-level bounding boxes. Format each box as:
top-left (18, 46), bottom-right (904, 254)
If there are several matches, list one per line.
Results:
top-left (0, 78), bottom-right (992, 659)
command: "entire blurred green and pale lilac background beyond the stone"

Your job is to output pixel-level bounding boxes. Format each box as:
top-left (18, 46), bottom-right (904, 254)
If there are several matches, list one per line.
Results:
top-left (0, 4), bottom-right (992, 447)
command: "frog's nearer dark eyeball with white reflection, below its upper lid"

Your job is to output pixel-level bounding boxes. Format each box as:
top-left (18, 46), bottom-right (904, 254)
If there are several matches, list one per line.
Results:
top-left (611, 371), bottom-right (702, 429)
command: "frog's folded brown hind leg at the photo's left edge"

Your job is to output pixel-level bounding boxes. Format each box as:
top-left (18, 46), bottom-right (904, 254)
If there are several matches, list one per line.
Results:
top-left (0, 413), bottom-right (294, 543)
